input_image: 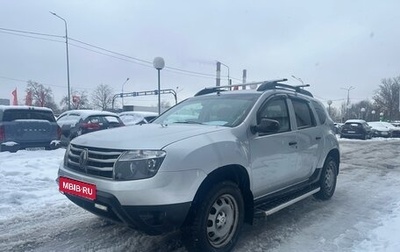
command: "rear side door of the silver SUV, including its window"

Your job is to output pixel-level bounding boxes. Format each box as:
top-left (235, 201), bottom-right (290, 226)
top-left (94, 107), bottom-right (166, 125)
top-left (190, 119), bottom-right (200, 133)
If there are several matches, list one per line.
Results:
top-left (290, 97), bottom-right (324, 179)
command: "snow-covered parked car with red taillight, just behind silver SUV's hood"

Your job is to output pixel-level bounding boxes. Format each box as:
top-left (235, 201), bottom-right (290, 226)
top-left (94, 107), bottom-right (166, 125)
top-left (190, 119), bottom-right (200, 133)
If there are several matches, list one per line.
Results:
top-left (57, 110), bottom-right (124, 145)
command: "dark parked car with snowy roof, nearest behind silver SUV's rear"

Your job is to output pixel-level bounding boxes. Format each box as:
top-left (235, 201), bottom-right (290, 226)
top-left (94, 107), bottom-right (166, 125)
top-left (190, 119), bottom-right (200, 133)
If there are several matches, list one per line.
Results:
top-left (340, 119), bottom-right (372, 140)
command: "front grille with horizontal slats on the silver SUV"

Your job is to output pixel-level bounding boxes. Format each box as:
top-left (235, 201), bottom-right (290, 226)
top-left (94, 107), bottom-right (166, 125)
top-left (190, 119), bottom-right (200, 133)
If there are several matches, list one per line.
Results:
top-left (67, 144), bottom-right (124, 179)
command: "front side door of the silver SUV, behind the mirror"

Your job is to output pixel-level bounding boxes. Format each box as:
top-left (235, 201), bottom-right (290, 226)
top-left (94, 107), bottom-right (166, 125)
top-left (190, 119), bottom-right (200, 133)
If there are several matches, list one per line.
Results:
top-left (249, 95), bottom-right (298, 198)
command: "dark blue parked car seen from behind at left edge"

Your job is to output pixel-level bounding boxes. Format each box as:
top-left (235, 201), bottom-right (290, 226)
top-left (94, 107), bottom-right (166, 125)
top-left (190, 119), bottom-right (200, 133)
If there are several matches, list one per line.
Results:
top-left (0, 106), bottom-right (61, 152)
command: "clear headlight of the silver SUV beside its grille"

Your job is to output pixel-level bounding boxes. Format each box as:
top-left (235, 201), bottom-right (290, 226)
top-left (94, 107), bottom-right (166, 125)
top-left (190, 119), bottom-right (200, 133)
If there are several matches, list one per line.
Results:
top-left (113, 150), bottom-right (166, 180)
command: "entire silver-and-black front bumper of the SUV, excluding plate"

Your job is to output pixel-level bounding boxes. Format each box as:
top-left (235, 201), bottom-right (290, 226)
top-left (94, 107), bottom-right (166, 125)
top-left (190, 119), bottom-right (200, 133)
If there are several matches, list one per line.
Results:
top-left (58, 164), bottom-right (206, 235)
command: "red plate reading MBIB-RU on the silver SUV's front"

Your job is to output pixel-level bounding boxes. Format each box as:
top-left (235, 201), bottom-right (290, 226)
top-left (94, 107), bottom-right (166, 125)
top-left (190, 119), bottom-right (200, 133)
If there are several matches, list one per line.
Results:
top-left (58, 177), bottom-right (96, 200)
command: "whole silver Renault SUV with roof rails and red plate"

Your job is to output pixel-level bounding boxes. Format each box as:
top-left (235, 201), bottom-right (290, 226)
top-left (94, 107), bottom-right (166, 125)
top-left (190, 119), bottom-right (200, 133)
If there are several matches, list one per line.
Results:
top-left (58, 79), bottom-right (340, 251)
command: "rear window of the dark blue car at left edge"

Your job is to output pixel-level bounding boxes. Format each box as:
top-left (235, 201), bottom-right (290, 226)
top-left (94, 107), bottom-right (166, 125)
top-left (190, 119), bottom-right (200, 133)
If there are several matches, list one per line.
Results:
top-left (3, 109), bottom-right (56, 122)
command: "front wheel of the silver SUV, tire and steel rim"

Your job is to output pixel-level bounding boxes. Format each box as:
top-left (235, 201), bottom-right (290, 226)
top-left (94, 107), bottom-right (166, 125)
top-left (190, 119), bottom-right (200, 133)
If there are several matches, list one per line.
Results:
top-left (183, 181), bottom-right (244, 252)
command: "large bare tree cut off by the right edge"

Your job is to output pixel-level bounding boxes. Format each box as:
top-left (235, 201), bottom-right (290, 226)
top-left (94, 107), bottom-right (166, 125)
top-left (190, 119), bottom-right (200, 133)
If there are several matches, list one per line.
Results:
top-left (373, 76), bottom-right (400, 120)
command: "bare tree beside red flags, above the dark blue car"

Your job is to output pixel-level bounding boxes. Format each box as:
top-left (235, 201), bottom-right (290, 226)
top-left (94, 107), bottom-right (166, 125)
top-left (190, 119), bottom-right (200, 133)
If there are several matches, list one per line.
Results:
top-left (26, 80), bottom-right (58, 111)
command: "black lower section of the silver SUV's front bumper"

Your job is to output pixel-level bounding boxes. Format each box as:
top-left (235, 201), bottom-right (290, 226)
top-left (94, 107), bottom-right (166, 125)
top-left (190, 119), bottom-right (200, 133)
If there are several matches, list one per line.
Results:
top-left (65, 191), bottom-right (191, 235)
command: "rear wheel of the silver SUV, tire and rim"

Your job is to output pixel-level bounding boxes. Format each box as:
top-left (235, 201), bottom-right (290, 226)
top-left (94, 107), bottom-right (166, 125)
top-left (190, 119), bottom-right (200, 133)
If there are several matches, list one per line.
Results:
top-left (314, 156), bottom-right (338, 200)
